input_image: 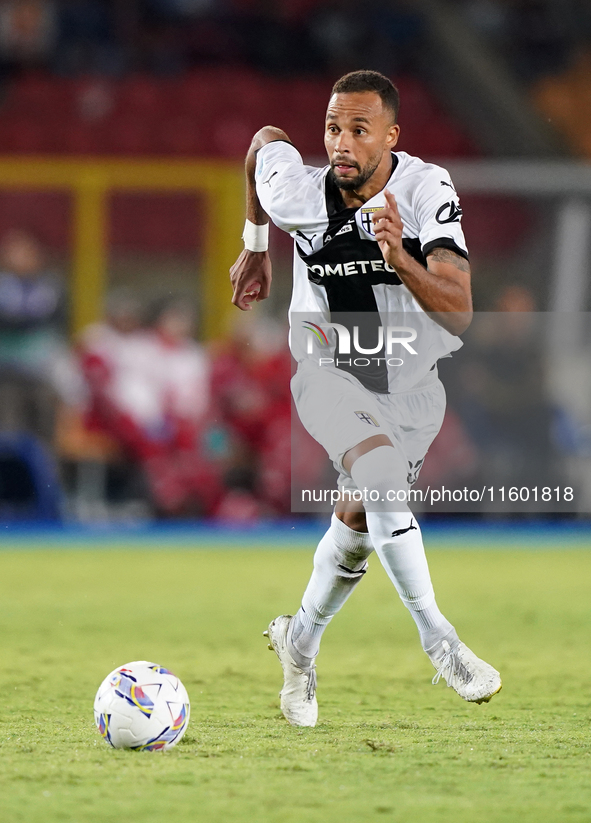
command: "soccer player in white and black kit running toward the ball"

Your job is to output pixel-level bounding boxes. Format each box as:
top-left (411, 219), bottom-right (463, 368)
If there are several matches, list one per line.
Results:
top-left (230, 71), bottom-right (501, 726)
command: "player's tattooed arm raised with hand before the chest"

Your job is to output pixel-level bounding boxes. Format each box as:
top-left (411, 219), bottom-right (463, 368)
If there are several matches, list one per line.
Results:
top-left (373, 191), bottom-right (472, 335)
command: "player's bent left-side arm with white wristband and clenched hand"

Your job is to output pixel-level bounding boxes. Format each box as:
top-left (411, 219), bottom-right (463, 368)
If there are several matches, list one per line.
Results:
top-left (230, 126), bottom-right (289, 311)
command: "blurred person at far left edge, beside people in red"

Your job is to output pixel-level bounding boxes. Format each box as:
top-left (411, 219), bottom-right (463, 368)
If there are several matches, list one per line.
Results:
top-left (0, 230), bottom-right (83, 440)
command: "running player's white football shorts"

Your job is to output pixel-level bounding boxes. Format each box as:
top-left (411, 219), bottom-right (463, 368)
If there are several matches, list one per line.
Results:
top-left (291, 360), bottom-right (445, 491)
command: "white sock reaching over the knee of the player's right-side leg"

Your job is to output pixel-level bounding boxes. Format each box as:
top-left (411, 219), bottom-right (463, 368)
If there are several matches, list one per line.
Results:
top-left (351, 446), bottom-right (453, 651)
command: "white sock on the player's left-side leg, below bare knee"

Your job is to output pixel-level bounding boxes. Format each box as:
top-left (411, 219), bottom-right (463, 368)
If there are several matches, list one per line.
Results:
top-left (287, 514), bottom-right (373, 668)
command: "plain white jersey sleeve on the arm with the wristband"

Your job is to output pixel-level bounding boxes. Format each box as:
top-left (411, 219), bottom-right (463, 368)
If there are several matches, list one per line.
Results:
top-left (255, 140), bottom-right (325, 233)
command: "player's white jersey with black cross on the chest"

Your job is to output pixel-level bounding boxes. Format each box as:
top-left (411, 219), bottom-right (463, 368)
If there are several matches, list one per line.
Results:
top-left (256, 140), bottom-right (468, 393)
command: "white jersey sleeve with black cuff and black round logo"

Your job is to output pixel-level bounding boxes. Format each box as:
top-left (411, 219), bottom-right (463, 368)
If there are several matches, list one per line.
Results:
top-left (414, 166), bottom-right (468, 259)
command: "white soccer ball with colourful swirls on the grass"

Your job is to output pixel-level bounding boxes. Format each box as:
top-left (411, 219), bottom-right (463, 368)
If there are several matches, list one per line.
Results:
top-left (94, 660), bottom-right (191, 751)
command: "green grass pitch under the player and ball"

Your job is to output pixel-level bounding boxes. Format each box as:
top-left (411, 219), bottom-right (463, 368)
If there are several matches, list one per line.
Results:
top-left (0, 547), bottom-right (591, 823)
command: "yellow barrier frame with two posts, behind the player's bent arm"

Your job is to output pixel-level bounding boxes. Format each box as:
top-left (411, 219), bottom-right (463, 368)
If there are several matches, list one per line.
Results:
top-left (0, 157), bottom-right (244, 338)
